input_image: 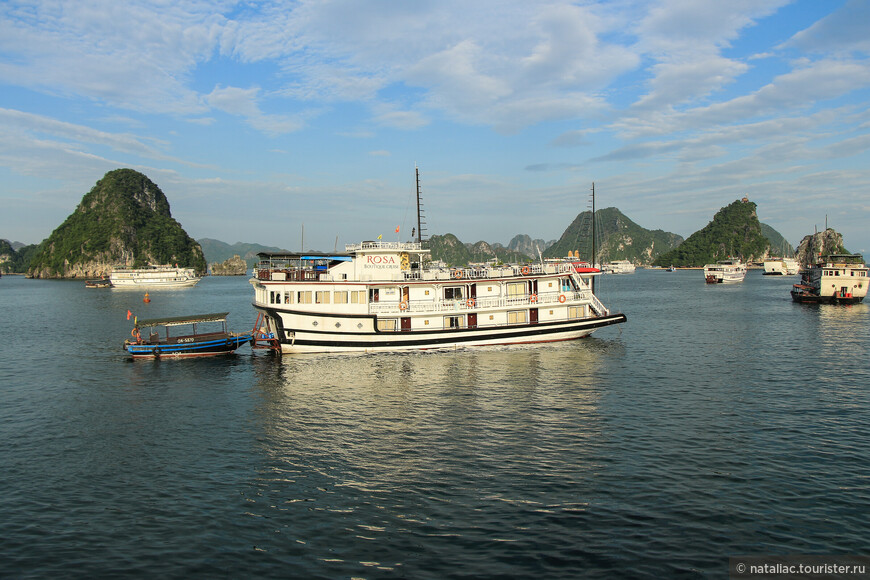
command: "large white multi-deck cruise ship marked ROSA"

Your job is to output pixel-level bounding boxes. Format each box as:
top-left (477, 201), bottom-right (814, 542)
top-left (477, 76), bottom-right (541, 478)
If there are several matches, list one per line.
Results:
top-left (251, 241), bottom-right (626, 353)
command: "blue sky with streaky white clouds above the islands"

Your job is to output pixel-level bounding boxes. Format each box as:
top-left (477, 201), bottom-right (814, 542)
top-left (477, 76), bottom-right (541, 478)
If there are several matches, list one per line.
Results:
top-left (0, 0), bottom-right (870, 253)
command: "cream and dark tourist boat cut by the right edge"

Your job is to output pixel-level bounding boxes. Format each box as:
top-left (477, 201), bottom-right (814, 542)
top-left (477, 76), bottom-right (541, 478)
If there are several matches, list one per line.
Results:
top-left (791, 254), bottom-right (868, 304)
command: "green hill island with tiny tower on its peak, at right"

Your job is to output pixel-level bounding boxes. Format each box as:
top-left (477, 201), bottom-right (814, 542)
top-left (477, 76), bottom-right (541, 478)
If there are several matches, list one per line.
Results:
top-left (653, 198), bottom-right (770, 268)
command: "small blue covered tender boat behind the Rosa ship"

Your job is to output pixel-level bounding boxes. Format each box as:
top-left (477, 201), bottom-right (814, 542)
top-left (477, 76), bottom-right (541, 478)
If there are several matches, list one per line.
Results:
top-left (124, 312), bottom-right (252, 359)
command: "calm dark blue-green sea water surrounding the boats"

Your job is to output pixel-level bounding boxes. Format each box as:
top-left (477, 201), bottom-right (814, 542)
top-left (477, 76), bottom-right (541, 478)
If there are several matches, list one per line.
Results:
top-left (0, 271), bottom-right (870, 578)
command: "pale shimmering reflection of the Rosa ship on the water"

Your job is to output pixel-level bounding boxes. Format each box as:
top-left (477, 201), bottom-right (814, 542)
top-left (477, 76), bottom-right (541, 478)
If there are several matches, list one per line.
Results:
top-left (249, 340), bottom-right (607, 572)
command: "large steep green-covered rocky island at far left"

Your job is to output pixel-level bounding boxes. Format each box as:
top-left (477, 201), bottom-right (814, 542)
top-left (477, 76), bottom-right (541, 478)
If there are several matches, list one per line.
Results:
top-left (28, 169), bottom-right (206, 278)
